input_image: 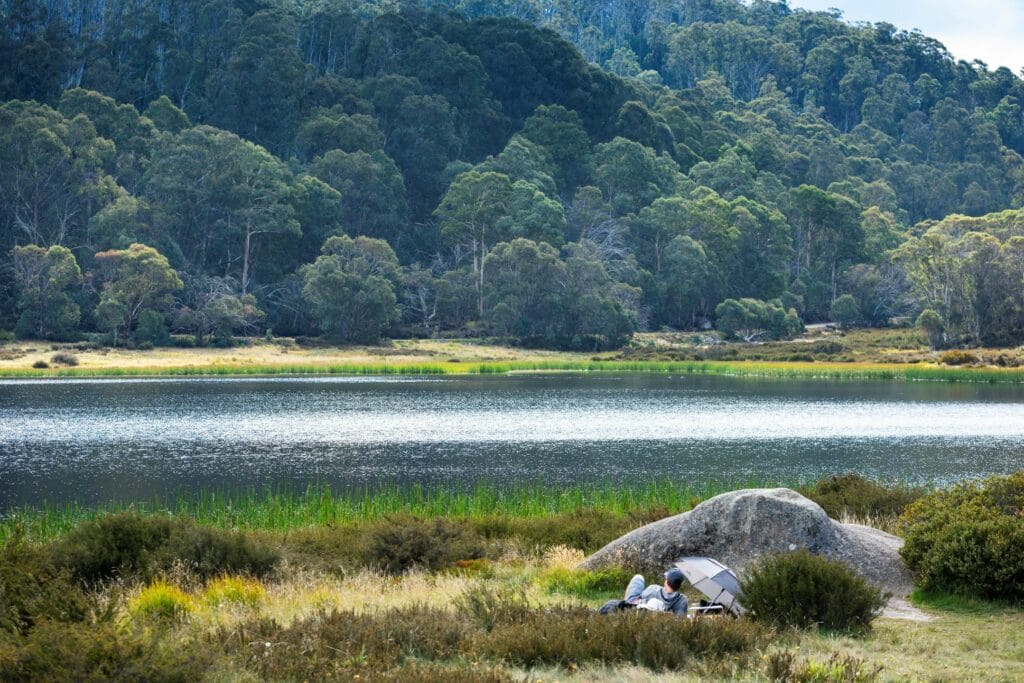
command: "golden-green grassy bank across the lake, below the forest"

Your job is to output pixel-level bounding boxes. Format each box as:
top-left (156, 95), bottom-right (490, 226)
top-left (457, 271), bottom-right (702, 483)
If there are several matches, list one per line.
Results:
top-left (6, 331), bottom-right (1024, 383)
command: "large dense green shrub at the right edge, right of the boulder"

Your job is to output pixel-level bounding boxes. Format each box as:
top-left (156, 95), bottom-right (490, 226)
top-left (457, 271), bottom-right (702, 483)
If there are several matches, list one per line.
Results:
top-left (900, 472), bottom-right (1024, 602)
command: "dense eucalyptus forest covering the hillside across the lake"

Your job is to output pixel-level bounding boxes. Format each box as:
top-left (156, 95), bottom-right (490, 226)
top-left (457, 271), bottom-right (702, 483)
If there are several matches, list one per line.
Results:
top-left (0, 0), bottom-right (1024, 348)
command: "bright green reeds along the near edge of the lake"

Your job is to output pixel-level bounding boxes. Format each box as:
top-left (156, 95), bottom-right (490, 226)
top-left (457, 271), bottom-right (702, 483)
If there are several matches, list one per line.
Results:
top-left (0, 480), bottom-right (776, 543)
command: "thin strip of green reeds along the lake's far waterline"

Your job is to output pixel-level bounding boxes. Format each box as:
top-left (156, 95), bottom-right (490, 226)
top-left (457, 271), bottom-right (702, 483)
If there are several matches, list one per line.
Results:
top-left (0, 360), bottom-right (1024, 383)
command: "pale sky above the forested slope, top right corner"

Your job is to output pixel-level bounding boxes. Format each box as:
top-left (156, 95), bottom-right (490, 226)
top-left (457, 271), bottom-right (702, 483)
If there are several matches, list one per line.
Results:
top-left (790, 0), bottom-right (1024, 75)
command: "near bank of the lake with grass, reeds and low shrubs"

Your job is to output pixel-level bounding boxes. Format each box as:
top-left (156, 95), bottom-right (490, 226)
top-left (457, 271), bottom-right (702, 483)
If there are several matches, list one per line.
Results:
top-left (0, 476), bottom-right (1024, 683)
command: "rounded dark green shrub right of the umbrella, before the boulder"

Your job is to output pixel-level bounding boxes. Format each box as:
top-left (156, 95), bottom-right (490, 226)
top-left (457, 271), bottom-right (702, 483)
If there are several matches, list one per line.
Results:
top-left (742, 549), bottom-right (886, 631)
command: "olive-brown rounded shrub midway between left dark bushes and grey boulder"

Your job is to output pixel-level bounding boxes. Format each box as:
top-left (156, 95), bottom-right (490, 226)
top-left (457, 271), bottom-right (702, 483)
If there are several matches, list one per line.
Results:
top-left (362, 517), bottom-right (484, 574)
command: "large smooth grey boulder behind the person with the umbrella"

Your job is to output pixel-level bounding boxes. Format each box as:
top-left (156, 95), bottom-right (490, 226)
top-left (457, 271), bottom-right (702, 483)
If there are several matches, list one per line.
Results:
top-left (581, 488), bottom-right (912, 596)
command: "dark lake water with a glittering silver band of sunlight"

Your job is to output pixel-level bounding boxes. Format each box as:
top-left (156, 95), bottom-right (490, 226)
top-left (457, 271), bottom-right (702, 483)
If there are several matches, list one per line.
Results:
top-left (0, 375), bottom-right (1024, 510)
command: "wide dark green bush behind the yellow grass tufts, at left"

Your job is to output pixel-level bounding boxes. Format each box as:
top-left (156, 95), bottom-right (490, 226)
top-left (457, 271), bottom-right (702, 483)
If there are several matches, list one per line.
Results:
top-left (51, 512), bottom-right (279, 583)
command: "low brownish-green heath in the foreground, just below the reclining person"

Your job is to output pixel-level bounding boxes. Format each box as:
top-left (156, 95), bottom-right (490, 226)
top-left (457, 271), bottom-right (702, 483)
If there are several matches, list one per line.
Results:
top-left (222, 593), bottom-right (772, 681)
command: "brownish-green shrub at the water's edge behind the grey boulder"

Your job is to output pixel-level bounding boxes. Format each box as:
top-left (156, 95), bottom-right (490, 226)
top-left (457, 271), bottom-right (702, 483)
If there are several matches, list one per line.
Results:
top-left (801, 472), bottom-right (924, 518)
